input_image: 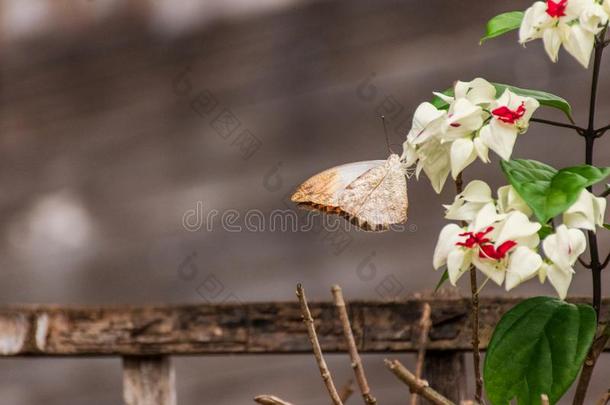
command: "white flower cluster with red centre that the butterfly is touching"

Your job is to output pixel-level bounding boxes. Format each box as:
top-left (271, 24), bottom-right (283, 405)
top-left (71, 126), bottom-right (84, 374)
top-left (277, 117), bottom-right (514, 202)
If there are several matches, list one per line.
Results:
top-left (402, 78), bottom-right (539, 193)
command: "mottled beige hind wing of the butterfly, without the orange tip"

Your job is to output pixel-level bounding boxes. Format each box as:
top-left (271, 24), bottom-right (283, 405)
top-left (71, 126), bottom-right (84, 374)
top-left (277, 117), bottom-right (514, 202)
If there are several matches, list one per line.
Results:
top-left (339, 155), bottom-right (408, 231)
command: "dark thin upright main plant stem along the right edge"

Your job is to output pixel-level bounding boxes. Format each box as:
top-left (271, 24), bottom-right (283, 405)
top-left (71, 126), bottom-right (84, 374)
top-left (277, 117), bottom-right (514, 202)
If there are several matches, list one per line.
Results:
top-left (573, 29), bottom-right (610, 405)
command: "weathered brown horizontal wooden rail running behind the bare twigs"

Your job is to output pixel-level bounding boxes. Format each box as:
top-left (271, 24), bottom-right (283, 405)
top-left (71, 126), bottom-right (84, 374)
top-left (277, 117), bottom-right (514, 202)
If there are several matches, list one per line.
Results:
top-left (0, 298), bottom-right (610, 356)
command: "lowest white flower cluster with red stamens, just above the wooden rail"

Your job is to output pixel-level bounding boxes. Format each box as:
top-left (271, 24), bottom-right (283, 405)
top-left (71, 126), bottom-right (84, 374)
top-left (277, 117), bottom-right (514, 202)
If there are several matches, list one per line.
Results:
top-left (433, 180), bottom-right (606, 299)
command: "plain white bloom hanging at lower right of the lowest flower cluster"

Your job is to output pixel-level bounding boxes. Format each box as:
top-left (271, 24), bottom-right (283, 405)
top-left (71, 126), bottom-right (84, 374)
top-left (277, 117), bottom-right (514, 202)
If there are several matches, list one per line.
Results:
top-left (539, 224), bottom-right (587, 299)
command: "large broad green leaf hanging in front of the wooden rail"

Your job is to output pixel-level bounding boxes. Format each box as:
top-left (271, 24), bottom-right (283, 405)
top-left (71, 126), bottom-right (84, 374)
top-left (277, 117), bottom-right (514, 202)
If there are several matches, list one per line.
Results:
top-left (484, 297), bottom-right (597, 405)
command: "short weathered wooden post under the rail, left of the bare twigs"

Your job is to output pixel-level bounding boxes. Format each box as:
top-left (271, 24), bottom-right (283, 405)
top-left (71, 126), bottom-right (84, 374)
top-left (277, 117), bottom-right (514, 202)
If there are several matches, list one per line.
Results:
top-left (123, 356), bottom-right (176, 405)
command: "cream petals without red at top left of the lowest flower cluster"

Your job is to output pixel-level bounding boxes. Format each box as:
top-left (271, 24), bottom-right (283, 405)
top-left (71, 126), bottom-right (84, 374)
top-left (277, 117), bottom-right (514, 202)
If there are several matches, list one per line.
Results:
top-left (444, 180), bottom-right (493, 222)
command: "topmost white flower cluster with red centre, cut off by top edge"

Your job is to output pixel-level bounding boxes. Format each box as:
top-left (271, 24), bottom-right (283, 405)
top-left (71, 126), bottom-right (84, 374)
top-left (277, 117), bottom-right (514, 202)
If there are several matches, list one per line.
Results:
top-left (519, 0), bottom-right (610, 68)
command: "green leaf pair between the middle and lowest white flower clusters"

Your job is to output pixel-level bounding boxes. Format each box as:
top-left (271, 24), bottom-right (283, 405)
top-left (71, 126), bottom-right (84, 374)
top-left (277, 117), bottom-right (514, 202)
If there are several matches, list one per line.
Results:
top-left (500, 159), bottom-right (610, 224)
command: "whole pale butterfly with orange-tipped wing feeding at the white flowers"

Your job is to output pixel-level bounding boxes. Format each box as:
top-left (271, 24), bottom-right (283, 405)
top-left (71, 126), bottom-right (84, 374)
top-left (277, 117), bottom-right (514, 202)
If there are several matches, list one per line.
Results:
top-left (291, 154), bottom-right (409, 232)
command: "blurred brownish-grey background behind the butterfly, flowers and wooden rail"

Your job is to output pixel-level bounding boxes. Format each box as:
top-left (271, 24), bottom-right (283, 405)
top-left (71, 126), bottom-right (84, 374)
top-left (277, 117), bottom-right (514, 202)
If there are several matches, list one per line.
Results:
top-left (0, 0), bottom-right (610, 405)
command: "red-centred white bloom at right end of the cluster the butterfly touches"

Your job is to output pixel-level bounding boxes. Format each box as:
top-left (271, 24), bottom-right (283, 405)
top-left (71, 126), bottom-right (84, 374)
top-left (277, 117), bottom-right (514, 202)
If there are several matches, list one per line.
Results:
top-left (480, 89), bottom-right (540, 160)
